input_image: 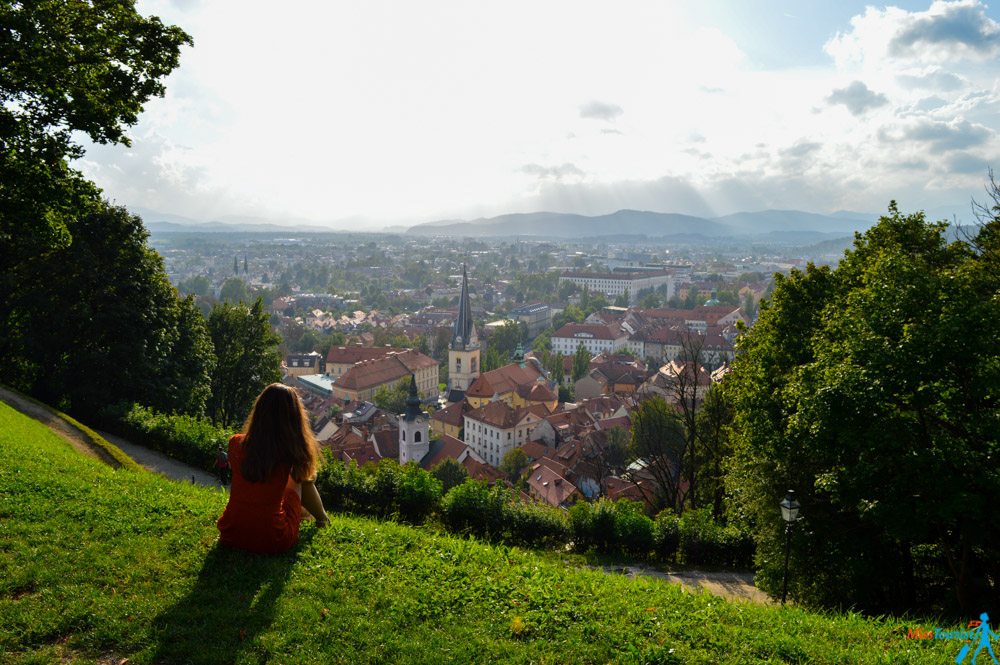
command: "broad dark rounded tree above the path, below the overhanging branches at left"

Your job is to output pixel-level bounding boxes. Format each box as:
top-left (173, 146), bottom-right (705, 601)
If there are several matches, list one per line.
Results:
top-left (19, 203), bottom-right (212, 414)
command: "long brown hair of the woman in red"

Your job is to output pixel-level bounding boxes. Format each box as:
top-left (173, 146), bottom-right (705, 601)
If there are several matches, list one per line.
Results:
top-left (241, 383), bottom-right (319, 483)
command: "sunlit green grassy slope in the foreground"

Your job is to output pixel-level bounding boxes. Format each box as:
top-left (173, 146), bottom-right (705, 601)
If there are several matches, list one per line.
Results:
top-left (0, 404), bottom-right (958, 663)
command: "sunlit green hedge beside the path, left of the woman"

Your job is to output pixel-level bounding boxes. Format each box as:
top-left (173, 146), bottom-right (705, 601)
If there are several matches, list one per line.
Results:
top-left (100, 404), bottom-right (231, 472)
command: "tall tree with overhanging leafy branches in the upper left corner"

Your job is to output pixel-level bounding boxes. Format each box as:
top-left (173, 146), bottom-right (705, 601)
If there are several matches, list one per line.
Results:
top-left (0, 2), bottom-right (190, 388)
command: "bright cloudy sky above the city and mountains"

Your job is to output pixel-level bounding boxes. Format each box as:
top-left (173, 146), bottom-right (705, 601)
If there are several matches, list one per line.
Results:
top-left (77, 0), bottom-right (1000, 229)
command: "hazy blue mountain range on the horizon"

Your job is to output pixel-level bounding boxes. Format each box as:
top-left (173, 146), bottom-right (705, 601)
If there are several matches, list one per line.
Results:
top-left (408, 210), bottom-right (874, 240)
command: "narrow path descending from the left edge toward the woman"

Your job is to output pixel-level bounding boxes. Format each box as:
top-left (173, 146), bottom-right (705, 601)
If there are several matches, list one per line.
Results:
top-left (0, 387), bottom-right (220, 487)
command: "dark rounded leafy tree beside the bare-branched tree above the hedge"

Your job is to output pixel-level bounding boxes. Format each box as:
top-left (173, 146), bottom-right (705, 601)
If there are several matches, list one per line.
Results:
top-left (629, 397), bottom-right (685, 513)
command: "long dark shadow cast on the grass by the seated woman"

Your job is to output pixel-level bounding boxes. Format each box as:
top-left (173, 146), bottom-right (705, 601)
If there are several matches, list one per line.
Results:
top-left (152, 529), bottom-right (313, 663)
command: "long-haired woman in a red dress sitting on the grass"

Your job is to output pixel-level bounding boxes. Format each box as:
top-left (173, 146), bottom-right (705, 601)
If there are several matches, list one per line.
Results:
top-left (217, 383), bottom-right (330, 554)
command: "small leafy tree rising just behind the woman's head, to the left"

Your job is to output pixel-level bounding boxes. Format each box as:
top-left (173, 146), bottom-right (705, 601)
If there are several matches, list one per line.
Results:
top-left (208, 298), bottom-right (281, 427)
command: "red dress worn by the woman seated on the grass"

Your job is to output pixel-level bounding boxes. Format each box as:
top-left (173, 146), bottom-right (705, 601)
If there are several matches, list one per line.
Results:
top-left (216, 434), bottom-right (302, 554)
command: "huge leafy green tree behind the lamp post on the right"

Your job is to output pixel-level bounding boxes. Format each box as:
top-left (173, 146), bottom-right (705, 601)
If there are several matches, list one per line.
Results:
top-left (727, 203), bottom-right (1000, 613)
